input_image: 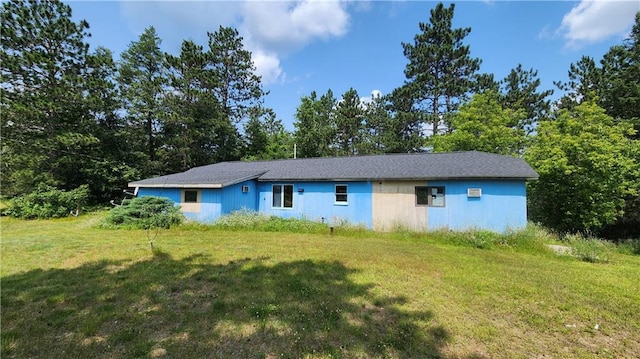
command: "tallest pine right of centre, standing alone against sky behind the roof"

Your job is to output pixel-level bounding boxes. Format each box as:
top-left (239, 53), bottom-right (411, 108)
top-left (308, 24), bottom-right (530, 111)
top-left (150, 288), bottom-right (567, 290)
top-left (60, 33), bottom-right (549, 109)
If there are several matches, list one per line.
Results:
top-left (402, 3), bottom-right (480, 135)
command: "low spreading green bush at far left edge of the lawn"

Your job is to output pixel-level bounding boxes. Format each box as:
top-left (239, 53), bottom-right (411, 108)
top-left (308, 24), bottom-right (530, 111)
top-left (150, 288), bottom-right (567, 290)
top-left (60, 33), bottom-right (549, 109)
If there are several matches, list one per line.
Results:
top-left (4, 184), bottom-right (89, 219)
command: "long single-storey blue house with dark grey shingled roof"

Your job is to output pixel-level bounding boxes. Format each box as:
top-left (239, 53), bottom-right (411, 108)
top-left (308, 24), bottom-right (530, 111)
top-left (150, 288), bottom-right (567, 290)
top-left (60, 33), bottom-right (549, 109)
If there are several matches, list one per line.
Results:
top-left (129, 151), bottom-right (538, 232)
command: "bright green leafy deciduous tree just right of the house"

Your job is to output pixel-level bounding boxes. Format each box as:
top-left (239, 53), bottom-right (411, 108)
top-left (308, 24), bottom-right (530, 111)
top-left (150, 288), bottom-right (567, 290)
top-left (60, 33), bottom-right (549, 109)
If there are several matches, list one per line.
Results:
top-left (525, 99), bottom-right (639, 232)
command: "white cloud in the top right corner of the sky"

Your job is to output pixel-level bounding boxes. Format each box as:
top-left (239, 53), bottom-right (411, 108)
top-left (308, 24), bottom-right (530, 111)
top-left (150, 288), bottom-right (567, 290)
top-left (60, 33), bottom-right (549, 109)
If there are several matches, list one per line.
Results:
top-left (559, 0), bottom-right (640, 48)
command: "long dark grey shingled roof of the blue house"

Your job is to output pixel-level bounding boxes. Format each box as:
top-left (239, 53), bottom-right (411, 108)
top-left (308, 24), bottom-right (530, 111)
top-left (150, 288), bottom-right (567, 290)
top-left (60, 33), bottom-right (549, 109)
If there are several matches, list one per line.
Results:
top-left (129, 151), bottom-right (538, 188)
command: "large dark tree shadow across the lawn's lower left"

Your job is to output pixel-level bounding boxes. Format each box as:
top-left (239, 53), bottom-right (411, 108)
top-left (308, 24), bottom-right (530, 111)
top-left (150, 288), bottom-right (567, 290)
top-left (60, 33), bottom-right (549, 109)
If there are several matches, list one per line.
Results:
top-left (1, 253), bottom-right (449, 358)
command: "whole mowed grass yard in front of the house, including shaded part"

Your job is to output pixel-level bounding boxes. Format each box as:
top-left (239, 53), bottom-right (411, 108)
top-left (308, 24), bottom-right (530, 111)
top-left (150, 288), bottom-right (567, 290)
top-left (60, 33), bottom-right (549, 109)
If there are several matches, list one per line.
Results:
top-left (0, 214), bottom-right (640, 358)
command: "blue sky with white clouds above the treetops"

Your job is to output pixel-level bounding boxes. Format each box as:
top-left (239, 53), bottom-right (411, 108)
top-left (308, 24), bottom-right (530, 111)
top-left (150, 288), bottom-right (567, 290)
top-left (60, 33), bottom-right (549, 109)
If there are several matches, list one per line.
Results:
top-left (67, 0), bottom-right (640, 130)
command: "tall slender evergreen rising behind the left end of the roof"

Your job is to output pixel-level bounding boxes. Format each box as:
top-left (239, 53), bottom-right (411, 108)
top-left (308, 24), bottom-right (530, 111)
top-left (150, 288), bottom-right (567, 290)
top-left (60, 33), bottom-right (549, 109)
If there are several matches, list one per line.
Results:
top-left (117, 27), bottom-right (168, 177)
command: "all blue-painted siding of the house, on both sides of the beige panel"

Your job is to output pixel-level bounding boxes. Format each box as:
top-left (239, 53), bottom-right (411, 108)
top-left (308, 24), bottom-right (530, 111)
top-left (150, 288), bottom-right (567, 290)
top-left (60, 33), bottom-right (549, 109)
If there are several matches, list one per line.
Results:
top-left (138, 180), bottom-right (527, 232)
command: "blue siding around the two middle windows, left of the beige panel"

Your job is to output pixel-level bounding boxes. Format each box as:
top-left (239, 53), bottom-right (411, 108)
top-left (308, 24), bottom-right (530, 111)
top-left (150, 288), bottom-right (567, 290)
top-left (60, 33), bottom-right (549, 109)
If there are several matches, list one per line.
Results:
top-left (258, 182), bottom-right (372, 228)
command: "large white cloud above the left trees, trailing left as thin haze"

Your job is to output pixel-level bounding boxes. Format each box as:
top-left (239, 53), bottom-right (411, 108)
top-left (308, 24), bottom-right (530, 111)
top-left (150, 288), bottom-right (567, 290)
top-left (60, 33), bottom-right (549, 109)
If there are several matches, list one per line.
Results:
top-left (121, 0), bottom-right (355, 84)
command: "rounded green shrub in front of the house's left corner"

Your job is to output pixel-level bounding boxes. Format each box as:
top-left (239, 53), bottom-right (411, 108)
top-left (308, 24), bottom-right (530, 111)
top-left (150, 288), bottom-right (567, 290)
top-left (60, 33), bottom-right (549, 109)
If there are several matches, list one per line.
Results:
top-left (105, 196), bottom-right (184, 229)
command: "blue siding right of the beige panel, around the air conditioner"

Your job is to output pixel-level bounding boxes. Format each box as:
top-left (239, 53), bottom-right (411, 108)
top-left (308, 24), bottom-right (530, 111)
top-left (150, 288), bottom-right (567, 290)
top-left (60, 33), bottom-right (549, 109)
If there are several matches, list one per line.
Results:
top-left (427, 180), bottom-right (527, 232)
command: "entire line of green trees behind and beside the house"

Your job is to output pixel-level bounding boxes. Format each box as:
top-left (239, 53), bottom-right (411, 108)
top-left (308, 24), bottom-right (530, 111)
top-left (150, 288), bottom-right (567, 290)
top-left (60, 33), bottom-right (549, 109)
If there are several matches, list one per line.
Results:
top-left (0, 0), bottom-right (640, 236)
